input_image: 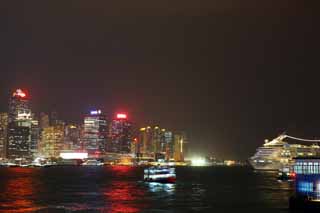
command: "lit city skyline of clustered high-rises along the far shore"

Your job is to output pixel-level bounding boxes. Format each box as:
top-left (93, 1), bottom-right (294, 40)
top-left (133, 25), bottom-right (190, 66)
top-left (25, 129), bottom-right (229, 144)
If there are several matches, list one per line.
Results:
top-left (0, 88), bottom-right (188, 164)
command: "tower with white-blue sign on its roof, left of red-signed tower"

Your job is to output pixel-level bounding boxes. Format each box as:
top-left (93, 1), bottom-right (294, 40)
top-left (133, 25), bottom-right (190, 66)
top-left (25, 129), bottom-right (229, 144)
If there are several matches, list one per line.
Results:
top-left (82, 110), bottom-right (107, 155)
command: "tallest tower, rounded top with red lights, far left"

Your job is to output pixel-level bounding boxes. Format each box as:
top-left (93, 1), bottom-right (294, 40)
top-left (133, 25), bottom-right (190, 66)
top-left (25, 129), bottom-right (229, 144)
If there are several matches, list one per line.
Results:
top-left (6, 89), bottom-right (32, 159)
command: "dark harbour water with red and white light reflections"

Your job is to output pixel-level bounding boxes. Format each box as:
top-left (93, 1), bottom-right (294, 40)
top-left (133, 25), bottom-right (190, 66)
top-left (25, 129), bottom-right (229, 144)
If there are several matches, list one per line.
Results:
top-left (0, 166), bottom-right (293, 213)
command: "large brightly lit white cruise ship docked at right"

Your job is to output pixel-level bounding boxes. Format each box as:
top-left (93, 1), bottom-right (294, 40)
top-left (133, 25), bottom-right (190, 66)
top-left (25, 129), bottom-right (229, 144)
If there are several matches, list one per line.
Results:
top-left (249, 135), bottom-right (320, 170)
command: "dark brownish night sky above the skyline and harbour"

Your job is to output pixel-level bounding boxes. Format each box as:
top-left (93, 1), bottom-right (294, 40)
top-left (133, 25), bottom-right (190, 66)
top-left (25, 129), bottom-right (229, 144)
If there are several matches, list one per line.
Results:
top-left (0, 0), bottom-right (320, 159)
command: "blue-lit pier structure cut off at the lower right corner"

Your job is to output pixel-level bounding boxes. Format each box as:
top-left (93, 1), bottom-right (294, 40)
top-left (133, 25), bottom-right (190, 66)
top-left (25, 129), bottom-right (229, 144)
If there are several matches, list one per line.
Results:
top-left (289, 156), bottom-right (320, 212)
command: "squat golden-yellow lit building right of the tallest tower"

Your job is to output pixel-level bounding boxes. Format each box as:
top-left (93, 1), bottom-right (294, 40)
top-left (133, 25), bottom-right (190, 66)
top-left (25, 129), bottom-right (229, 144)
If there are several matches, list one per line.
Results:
top-left (39, 125), bottom-right (64, 158)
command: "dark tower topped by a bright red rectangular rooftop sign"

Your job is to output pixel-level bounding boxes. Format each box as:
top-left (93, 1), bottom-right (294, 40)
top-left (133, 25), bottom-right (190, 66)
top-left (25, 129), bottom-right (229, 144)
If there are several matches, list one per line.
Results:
top-left (107, 114), bottom-right (133, 154)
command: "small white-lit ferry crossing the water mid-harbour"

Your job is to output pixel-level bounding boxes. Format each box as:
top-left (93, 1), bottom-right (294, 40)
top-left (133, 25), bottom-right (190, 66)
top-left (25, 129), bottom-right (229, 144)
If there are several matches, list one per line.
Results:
top-left (144, 166), bottom-right (176, 183)
